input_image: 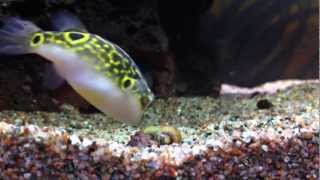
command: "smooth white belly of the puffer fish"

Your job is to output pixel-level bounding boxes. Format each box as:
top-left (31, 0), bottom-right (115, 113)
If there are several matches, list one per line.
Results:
top-left (36, 45), bottom-right (142, 123)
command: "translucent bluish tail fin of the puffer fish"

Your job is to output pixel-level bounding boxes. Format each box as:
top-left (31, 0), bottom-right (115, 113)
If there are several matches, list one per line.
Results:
top-left (0, 17), bottom-right (41, 54)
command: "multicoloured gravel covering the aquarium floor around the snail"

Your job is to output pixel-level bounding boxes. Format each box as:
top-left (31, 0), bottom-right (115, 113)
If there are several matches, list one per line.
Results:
top-left (0, 81), bottom-right (320, 179)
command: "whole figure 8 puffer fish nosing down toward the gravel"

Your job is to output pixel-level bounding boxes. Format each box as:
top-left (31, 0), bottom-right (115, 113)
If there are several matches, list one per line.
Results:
top-left (0, 13), bottom-right (154, 124)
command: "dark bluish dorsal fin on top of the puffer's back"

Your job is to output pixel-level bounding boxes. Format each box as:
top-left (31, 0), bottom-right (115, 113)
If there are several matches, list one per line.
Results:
top-left (51, 11), bottom-right (87, 32)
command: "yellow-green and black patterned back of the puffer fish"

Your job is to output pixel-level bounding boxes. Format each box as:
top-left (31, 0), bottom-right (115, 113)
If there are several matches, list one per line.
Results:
top-left (30, 31), bottom-right (142, 91)
